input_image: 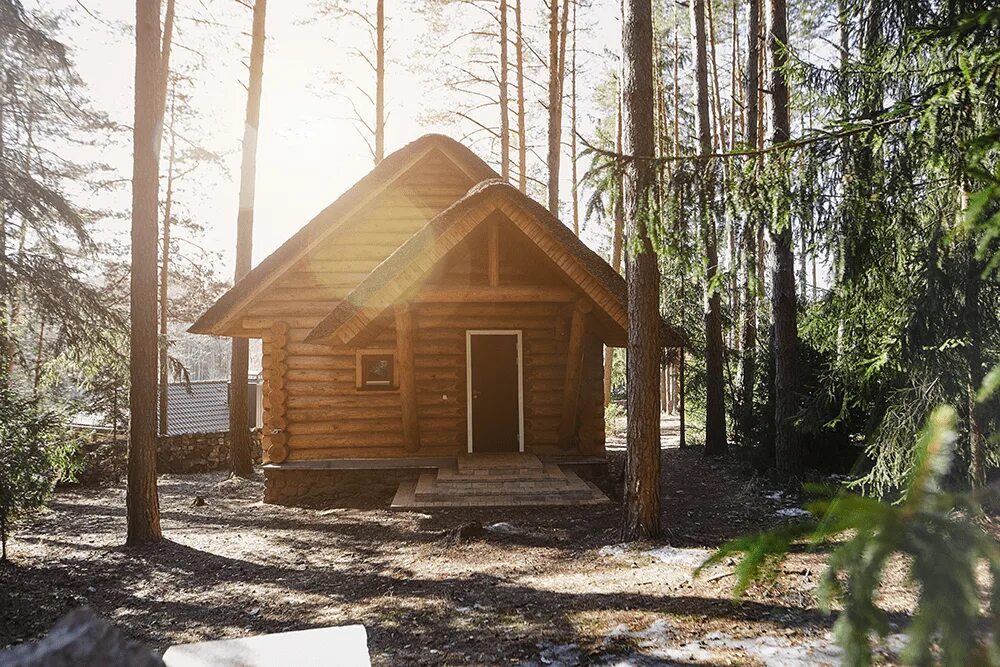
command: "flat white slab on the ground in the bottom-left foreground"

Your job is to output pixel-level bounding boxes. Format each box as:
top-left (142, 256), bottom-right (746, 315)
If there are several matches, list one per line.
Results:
top-left (163, 625), bottom-right (371, 667)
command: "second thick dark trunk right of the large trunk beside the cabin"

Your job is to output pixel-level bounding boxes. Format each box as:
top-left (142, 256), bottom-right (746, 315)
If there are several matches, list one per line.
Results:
top-left (768, 0), bottom-right (802, 480)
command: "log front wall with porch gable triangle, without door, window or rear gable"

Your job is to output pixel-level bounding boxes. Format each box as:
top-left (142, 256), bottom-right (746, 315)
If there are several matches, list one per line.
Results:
top-left (264, 216), bottom-right (604, 462)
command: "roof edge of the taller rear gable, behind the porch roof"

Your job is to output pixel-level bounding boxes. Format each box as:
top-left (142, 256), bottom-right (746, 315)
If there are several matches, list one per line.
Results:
top-left (188, 134), bottom-right (498, 334)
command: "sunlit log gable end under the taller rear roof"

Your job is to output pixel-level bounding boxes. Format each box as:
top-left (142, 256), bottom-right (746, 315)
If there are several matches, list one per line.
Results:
top-left (228, 150), bottom-right (474, 337)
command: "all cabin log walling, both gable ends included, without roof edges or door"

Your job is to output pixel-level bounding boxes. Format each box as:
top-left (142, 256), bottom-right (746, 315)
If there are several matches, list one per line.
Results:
top-left (227, 152), bottom-right (604, 463)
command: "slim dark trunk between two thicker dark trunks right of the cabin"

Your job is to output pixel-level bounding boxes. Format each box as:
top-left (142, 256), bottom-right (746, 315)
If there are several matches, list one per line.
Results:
top-left (737, 0), bottom-right (761, 444)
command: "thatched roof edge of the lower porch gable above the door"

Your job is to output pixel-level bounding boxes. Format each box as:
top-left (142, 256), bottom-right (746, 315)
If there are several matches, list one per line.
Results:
top-left (306, 179), bottom-right (681, 346)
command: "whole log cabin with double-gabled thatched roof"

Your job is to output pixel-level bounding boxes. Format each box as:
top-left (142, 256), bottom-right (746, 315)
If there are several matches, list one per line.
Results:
top-left (190, 135), bottom-right (680, 505)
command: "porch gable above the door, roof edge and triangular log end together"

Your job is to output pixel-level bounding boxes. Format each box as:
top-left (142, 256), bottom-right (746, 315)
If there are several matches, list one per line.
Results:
top-left (309, 183), bottom-right (627, 345)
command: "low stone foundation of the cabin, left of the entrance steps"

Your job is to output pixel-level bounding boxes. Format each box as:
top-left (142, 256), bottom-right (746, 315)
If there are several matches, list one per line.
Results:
top-left (264, 466), bottom-right (423, 507)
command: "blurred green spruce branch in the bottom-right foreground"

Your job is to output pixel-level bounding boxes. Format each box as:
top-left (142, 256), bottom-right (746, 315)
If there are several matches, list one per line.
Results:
top-left (699, 407), bottom-right (1000, 667)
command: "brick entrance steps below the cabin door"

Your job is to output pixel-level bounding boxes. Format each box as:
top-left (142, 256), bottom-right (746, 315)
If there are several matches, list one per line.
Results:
top-left (392, 454), bottom-right (609, 508)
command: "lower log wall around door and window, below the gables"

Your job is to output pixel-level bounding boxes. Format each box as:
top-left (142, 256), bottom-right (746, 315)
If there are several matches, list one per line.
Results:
top-left (252, 303), bottom-right (604, 463)
